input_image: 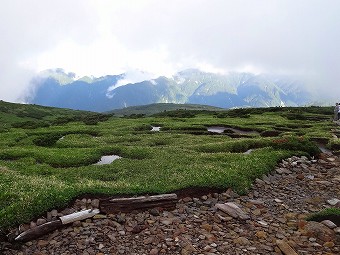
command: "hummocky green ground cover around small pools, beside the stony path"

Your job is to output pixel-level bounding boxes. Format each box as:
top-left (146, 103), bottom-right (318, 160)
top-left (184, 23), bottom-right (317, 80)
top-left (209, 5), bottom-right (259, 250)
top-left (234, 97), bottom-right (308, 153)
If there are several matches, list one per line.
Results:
top-left (0, 105), bottom-right (336, 229)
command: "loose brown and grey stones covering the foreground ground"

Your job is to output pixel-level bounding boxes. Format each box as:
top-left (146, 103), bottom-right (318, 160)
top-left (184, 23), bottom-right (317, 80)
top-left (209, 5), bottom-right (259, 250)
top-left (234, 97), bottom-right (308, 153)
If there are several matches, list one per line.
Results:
top-left (0, 154), bottom-right (340, 255)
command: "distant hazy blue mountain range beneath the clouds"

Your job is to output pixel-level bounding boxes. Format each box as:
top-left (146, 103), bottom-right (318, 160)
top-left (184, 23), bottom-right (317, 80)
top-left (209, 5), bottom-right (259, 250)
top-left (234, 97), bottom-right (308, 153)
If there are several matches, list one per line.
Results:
top-left (24, 69), bottom-right (316, 112)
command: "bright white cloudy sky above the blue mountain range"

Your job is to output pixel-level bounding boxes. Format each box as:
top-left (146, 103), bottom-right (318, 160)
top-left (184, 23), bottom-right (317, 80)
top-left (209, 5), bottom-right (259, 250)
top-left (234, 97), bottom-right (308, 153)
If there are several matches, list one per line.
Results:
top-left (0, 0), bottom-right (340, 102)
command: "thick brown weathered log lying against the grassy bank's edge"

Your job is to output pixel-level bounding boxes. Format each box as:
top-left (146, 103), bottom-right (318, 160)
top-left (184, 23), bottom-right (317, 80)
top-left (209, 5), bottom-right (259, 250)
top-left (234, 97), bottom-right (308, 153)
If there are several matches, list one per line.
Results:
top-left (100, 194), bottom-right (178, 213)
